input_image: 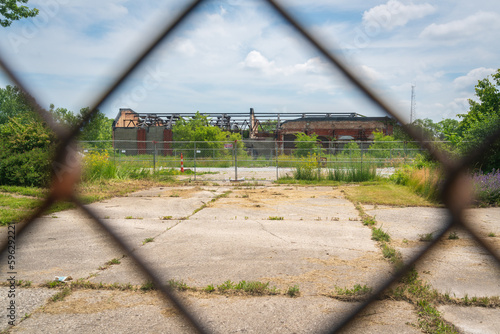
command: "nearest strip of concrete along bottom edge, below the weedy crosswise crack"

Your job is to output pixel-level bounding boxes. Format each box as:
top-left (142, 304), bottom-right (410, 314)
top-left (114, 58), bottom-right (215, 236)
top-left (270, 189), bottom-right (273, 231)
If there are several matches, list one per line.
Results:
top-left (8, 290), bottom-right (419, 334)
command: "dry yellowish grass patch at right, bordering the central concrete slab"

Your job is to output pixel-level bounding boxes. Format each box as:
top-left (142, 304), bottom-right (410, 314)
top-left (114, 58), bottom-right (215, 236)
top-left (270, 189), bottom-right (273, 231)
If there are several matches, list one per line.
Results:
top-left (343, 181), bottom-right (437, 207)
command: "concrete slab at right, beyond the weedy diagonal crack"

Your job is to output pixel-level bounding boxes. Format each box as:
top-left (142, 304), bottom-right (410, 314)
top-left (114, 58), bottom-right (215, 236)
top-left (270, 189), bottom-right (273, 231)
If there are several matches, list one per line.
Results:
top-left (366, 207), bottom-right (500, 298)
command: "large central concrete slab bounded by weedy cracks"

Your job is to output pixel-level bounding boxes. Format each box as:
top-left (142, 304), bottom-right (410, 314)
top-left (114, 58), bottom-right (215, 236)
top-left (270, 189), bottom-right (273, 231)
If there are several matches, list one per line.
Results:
top-left (92, 188), bottom-right (392, 294)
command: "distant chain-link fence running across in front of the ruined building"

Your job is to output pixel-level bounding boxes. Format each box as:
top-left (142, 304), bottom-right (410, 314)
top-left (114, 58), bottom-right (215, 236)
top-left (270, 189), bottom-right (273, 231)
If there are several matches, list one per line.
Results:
top-left (78, 140), bottom-right (432, 181)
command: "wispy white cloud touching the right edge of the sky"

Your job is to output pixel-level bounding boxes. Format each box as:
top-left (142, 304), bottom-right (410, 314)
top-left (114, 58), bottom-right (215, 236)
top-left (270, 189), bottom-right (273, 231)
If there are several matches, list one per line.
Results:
top-left (420, 12), bottom-right (500, 41)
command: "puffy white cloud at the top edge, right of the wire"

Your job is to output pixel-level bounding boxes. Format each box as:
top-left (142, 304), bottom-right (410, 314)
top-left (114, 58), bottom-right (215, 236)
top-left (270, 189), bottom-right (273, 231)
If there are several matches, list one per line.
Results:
top-left (363, 0), bottom-right (436, 30)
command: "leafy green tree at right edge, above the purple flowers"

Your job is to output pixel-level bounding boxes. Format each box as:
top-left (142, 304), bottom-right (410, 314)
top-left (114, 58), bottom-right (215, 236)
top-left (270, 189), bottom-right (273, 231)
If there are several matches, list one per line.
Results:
top-left (452, 69), bottom-right (500, 172)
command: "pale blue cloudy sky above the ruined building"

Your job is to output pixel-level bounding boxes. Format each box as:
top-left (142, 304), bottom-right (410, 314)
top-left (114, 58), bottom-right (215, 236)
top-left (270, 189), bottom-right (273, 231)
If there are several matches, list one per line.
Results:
top-left (0, 0), bottom-right (500, 122)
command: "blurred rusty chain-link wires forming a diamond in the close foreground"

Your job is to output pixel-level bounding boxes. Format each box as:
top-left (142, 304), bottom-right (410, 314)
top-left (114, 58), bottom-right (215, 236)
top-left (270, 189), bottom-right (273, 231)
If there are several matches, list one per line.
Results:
top-left (0, 0), bottom-right (500, 332)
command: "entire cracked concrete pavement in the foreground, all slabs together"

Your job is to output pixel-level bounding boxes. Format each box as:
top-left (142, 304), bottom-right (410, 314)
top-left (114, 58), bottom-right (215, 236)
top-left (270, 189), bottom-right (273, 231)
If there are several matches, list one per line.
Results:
top-left (0, 183), bottom-right (500, 333)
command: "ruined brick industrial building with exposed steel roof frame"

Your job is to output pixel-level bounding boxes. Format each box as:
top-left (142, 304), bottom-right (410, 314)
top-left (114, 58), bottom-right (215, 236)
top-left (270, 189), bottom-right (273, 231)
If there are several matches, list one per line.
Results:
top-left (113, 108), bottom-right (394, 155)
